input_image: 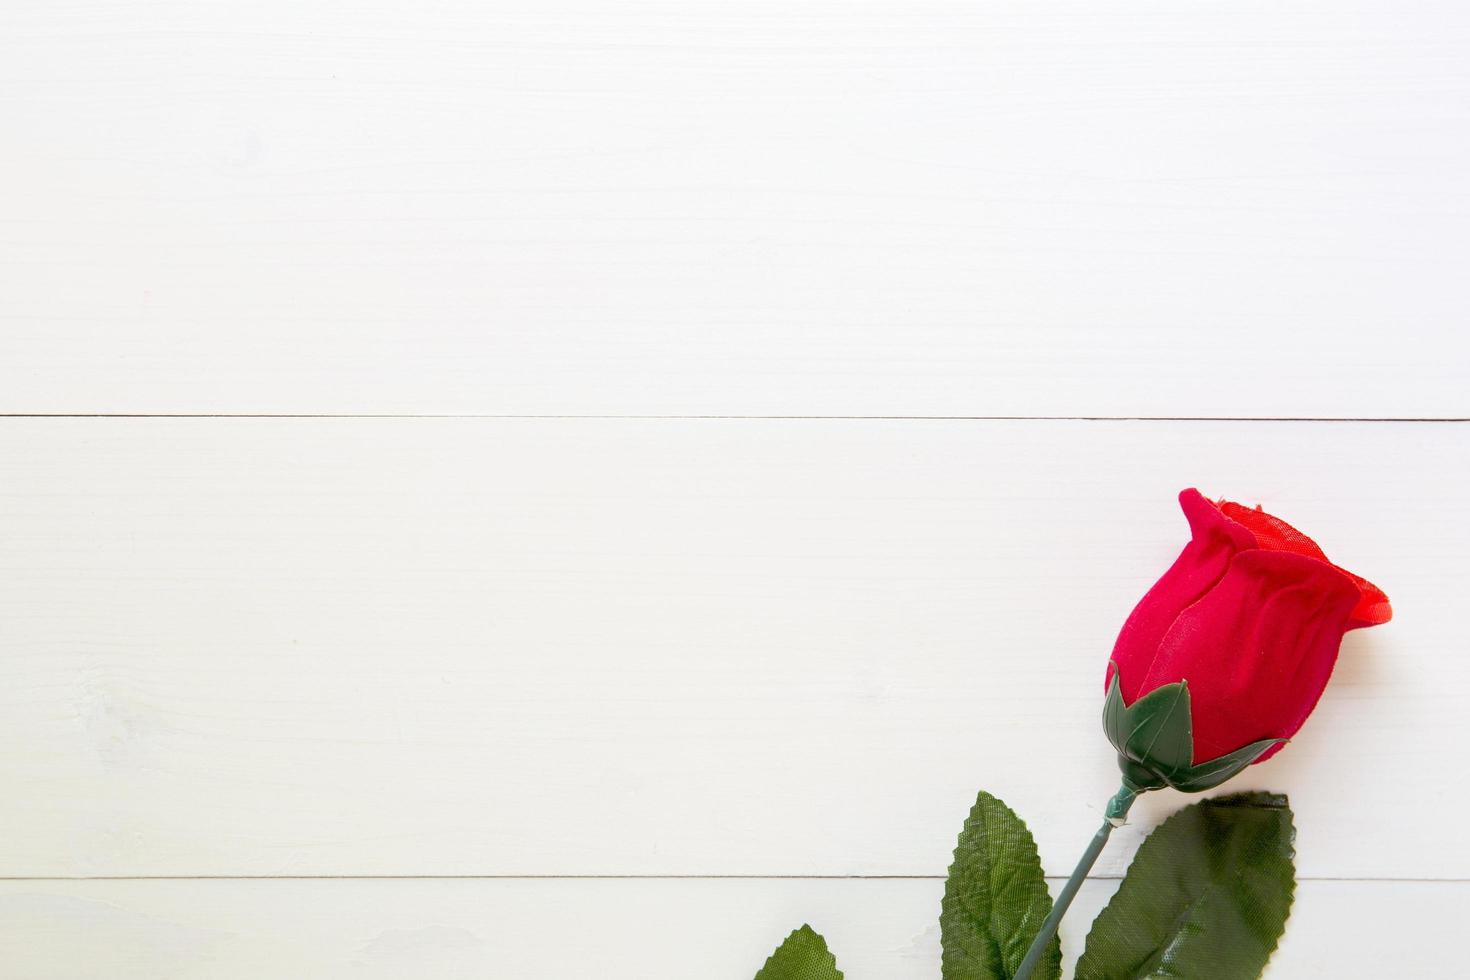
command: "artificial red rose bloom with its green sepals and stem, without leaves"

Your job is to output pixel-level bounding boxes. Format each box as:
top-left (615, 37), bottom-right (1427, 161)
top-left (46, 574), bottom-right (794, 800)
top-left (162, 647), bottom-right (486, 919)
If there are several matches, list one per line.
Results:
top-left (1014, 489), bottom-right (1394, 980)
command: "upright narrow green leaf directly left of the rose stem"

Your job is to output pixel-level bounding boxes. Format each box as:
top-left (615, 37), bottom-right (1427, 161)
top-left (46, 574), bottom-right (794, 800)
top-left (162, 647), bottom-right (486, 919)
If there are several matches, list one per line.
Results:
top-left (939, 793), bottom-right (1061, 980)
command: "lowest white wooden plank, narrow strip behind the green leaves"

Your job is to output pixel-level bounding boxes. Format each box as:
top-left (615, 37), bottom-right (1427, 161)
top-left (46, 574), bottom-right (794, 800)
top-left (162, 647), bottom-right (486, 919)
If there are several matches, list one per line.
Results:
top-left (0, 879), bottom-right (1446, 980)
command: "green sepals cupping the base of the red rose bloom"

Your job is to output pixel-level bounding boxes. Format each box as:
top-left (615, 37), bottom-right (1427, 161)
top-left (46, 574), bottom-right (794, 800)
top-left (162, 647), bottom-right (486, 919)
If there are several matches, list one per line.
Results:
top-left (1103, 664), bottom-right (1286, 793)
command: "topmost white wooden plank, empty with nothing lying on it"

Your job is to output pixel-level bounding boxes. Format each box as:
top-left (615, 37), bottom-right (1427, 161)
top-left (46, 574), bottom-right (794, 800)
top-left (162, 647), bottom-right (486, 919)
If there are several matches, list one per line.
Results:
top-left (0, 0), bottom-right (1470, 417)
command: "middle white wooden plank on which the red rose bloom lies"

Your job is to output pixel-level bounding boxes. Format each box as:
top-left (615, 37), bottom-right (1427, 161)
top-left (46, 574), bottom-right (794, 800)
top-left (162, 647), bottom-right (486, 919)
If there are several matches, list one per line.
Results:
top-left (0, 419), bottom-right (1470, 879)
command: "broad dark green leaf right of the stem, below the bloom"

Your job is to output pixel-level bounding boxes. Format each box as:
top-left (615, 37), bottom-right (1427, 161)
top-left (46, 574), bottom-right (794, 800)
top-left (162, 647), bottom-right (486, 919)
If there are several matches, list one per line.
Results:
top-left (1076, 793), bottom-right (1297, 980)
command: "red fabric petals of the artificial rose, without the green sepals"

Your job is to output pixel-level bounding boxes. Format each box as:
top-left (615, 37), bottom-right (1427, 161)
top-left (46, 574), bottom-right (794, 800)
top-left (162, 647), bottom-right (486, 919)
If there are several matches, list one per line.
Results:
top-left (1108, 489), bottom-right (1392, 765)
